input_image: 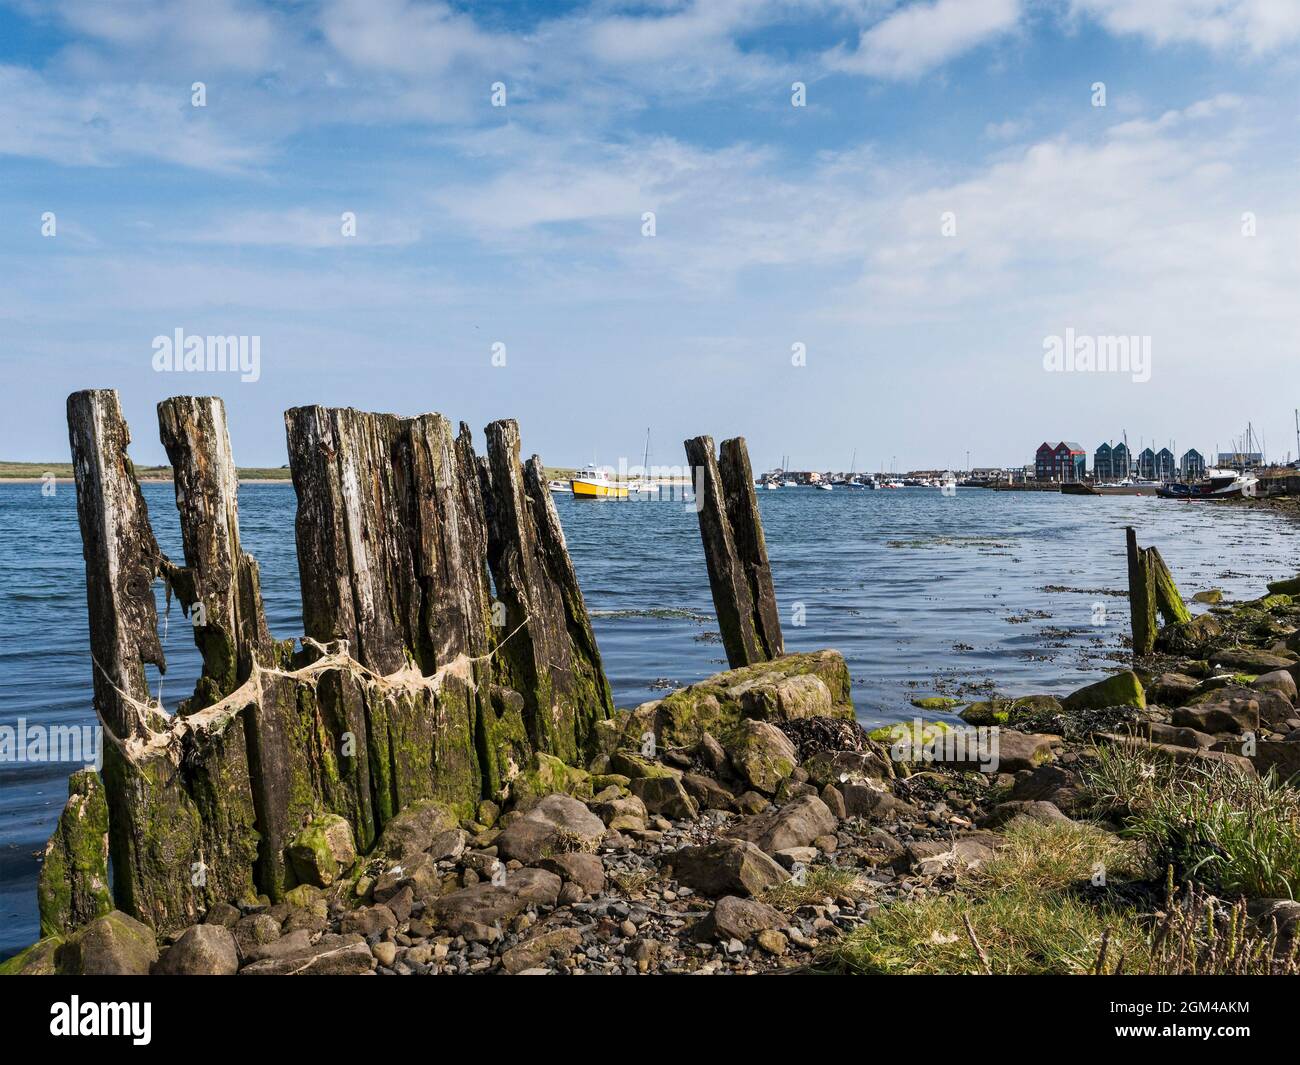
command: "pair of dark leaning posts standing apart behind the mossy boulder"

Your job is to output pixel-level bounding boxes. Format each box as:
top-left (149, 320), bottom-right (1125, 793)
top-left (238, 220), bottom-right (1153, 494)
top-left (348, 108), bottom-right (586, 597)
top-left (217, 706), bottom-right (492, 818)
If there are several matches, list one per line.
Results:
top-left (685, 437), bottom-right (784, 668)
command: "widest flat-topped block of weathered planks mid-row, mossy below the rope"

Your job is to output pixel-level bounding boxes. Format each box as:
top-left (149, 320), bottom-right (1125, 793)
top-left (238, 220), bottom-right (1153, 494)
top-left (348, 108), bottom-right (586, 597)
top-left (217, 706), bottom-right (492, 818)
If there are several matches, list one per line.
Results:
top-left (285, 407), bottom-right (490, 827)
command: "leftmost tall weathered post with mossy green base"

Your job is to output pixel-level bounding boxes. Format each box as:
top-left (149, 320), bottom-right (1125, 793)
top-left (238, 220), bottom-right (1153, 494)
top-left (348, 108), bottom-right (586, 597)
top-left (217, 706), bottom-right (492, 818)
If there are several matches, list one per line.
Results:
top-left (68, 389), bottom-right (202, 928)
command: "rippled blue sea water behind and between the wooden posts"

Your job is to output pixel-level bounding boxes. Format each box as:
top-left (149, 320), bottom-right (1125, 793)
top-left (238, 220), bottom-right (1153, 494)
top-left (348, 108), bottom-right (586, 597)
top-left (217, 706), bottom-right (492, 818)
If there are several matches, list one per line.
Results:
top-left (0, 484), bottom-right (1300, 957)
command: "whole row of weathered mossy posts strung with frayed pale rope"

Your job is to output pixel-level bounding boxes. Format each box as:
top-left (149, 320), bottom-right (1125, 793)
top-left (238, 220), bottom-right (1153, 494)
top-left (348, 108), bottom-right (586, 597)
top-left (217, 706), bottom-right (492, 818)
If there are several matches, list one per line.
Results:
top-left (57, 390), bottom-right (614, 930)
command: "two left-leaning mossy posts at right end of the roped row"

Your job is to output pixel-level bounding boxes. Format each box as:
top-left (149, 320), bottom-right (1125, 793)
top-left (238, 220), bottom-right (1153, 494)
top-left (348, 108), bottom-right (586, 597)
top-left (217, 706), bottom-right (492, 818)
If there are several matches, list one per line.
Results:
top-left (484, 420), bottom-right (614, 763)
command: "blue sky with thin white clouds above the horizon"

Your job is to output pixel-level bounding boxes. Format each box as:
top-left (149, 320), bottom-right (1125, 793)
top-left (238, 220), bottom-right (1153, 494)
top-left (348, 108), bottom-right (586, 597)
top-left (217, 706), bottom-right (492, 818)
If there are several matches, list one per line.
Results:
top-left (0, 0), bottom-right (1300, 468)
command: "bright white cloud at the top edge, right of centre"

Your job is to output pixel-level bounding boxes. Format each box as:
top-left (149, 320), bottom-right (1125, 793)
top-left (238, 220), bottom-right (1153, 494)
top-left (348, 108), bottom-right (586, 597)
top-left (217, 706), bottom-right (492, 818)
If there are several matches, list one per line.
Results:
top-left (828, 0), bottom-right (1021, 79)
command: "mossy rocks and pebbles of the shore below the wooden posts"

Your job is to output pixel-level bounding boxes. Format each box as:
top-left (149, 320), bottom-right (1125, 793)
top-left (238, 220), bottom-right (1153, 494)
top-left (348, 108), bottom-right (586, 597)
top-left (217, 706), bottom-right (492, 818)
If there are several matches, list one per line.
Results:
top-left (4, 553), bottom-right (1300, 975)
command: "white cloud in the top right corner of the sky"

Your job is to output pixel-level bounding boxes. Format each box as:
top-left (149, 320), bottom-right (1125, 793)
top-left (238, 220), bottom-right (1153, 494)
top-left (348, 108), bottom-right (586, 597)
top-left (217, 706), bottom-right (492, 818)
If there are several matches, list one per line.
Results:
top-left (1073, 0), bottom-right (1300, 55)
